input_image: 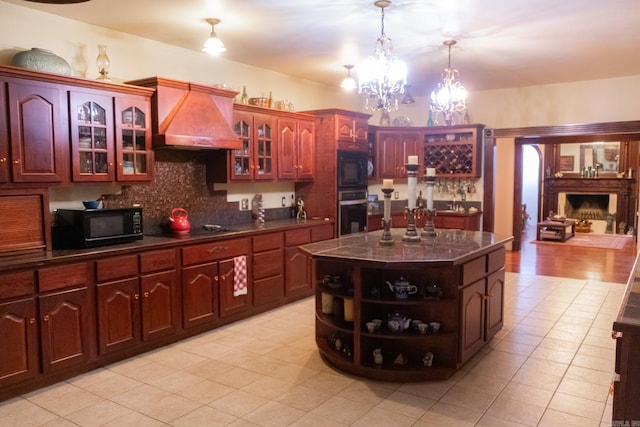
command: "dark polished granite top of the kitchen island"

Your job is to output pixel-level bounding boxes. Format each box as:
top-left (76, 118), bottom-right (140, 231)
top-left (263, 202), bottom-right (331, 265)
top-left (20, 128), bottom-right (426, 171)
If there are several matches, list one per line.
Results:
top-left (301, 228), bottom-right (513, 265)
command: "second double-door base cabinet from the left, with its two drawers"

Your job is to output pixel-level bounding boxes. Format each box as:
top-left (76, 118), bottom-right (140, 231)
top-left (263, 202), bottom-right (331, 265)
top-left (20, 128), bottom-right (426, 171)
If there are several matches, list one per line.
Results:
top-left (96, 249), bottom-right (179, 354)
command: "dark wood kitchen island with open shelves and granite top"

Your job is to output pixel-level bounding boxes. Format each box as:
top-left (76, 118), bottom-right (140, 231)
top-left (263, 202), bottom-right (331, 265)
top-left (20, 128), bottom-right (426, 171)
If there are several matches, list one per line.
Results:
top-left (301, 229), bottom-right (512, 381)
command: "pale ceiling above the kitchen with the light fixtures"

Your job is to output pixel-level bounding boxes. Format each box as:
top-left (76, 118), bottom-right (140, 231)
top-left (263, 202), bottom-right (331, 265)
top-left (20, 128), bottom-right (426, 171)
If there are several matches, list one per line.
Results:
top-left (2, 0), bottom-right (640, 96)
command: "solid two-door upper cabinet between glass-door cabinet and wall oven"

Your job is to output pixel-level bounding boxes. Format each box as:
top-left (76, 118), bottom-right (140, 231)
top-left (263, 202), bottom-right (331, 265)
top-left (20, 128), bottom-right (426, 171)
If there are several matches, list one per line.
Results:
top-left (278, 118), bottom-right (315, 181)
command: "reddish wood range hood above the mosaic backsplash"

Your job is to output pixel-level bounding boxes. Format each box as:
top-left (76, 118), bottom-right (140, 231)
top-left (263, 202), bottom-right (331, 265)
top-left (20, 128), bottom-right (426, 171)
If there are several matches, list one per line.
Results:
top-left (127, 77), bottom-right (242, 149)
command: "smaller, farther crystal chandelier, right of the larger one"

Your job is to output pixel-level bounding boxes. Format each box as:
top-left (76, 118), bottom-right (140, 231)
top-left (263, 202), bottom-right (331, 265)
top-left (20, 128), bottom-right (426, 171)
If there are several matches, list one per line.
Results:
top-left (431, 40), bottom-right (467, 126)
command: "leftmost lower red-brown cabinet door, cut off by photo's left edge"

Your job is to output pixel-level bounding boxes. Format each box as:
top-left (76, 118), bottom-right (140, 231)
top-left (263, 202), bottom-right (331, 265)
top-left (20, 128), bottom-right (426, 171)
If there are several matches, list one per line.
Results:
top-left (0, 298), bottom-right (39, 387)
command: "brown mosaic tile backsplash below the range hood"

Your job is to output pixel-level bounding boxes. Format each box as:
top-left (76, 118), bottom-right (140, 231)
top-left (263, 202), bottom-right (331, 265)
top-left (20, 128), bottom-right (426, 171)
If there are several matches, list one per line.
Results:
top-left (104, 150), bottom-right (290, 234)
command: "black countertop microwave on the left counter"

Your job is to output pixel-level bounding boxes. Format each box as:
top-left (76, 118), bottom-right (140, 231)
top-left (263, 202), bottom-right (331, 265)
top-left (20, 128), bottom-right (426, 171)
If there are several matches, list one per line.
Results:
top-left (52, 207), bottom-right (142, 249)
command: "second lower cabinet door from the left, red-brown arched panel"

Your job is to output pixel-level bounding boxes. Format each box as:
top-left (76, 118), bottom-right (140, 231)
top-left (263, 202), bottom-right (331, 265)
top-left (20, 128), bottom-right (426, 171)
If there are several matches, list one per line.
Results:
top-left (39, 288), bottom-right (95, 374)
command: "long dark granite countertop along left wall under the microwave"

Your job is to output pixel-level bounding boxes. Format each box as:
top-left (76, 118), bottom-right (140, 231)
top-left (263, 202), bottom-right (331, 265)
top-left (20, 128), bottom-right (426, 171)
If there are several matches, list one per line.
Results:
top-left (0, 219), bottom-right (333, 272)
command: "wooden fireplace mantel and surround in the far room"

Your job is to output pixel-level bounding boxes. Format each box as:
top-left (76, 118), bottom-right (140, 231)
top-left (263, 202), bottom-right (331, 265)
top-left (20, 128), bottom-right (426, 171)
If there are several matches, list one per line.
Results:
top-left (542, 178), bottom-right (637, 231)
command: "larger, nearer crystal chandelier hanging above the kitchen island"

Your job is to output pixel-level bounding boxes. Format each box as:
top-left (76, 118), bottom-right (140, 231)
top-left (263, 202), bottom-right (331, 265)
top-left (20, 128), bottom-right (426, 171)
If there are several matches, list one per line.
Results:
top-left (358, 0), bottom-right (407, 111)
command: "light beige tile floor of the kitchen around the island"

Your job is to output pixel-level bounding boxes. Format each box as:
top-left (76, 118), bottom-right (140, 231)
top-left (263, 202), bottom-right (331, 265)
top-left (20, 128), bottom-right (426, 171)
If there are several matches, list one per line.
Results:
top-left (0, 273), bottom-right (624, 427)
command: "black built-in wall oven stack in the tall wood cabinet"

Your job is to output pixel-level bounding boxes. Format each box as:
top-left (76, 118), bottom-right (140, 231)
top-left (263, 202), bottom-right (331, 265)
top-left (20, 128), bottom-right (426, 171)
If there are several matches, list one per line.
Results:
top-left (337, 151), bottom-right (368, 235)
